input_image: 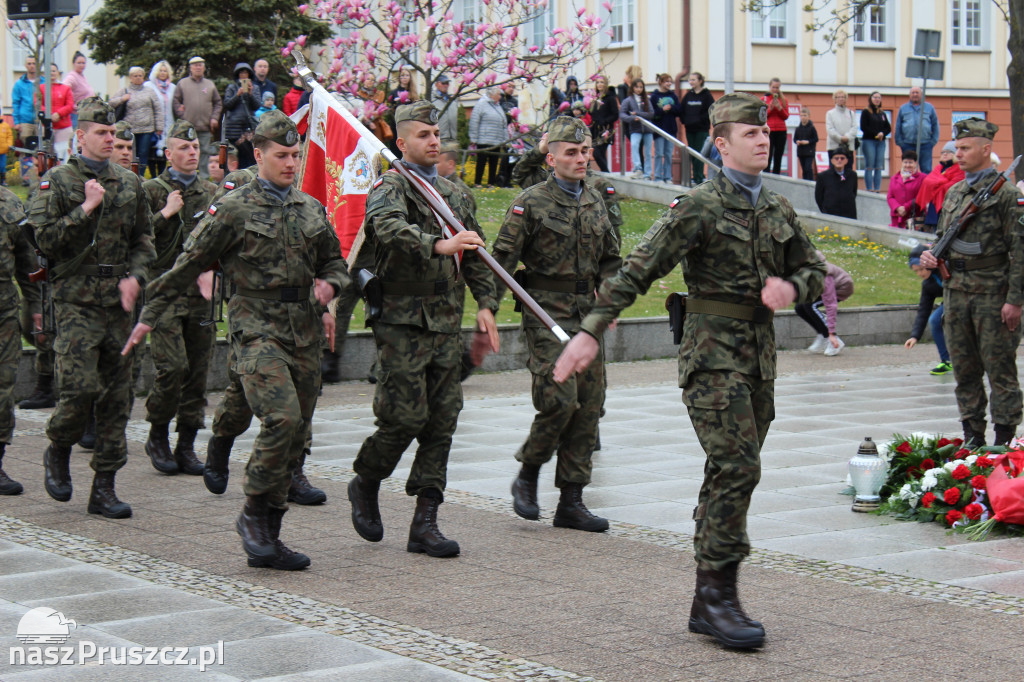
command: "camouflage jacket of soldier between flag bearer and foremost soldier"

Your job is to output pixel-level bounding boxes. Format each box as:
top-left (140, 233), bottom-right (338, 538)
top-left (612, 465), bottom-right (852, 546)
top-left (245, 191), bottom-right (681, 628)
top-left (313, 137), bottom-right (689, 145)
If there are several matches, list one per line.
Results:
top-left (495, 175), bottom-right (622, 332)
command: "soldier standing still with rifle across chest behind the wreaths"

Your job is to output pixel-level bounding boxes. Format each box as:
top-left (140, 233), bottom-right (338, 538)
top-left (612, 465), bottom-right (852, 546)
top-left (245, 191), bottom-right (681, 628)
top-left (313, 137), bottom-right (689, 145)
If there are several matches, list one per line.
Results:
top-left (921, 118), bottom-right (1024, 447)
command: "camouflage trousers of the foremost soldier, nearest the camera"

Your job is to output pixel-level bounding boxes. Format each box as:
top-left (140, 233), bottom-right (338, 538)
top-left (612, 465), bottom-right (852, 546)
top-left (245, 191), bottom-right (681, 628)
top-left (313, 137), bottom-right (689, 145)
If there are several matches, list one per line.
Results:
top-left (683, 371), bottom-right (775, 570)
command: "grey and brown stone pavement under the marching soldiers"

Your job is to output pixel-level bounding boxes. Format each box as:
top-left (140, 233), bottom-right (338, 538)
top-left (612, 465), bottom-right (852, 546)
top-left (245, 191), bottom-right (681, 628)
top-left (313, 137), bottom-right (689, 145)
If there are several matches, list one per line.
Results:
top-left (0, 347), bottom-right (1024, 680)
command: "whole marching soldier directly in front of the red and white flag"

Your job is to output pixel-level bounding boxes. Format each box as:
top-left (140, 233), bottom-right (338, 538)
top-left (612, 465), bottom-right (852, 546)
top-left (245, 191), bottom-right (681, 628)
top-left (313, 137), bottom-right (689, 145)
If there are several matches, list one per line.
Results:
top-left (125, 111), bottom-right (348, 570)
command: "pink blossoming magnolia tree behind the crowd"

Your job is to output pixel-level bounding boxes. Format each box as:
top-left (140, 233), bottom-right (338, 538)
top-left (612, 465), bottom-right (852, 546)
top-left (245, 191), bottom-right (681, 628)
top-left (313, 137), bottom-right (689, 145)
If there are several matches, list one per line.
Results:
top-left (283, 0), bottom-right (610, 128)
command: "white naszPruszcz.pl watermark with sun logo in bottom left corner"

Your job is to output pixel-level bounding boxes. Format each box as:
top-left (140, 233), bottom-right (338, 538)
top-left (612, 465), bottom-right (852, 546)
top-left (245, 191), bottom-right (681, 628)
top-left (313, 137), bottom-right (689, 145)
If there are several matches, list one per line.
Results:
top-left (9, 606), bottom-right (224, 673)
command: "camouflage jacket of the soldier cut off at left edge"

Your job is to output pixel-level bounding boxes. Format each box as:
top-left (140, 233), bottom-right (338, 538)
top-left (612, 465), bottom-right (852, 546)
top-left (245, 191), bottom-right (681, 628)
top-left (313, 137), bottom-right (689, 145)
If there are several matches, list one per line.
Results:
top-left (0, 187), bottom-right (41, 321)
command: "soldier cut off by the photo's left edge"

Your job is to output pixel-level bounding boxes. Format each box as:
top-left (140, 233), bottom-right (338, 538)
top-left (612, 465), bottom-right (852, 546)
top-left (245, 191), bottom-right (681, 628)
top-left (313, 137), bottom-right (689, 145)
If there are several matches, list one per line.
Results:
top-left (0, 187), bottom-right (43, 495)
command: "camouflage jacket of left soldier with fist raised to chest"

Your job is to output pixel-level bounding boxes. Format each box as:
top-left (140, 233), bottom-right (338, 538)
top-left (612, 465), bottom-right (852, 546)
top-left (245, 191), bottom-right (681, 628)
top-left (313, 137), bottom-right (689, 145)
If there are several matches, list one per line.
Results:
top-left (29, 157), bottom-right (156, 306)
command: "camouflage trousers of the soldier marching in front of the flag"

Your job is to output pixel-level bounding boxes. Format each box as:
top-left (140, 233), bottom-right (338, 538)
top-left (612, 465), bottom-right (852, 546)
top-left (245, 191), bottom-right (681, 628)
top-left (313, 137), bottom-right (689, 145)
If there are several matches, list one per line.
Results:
top-left (232, 338), bottom-right (321, 509)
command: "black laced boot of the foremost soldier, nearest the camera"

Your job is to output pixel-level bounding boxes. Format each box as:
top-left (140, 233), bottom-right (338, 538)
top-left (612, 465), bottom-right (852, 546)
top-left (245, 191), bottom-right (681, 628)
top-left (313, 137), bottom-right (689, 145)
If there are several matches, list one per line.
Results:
top-left (689, 564), bottom-right (765, 649)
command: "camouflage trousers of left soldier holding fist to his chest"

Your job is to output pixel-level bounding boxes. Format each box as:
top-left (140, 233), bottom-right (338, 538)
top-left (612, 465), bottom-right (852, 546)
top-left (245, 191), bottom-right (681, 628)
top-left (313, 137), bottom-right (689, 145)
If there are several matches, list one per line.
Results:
top-left (46, 301), bottom-right (132, 473)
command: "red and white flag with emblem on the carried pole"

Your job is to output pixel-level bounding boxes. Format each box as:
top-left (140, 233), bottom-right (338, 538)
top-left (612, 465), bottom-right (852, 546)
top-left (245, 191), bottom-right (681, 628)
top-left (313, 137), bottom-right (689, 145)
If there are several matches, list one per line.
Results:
top-left (301, 88), bottom-right (380, 258)
